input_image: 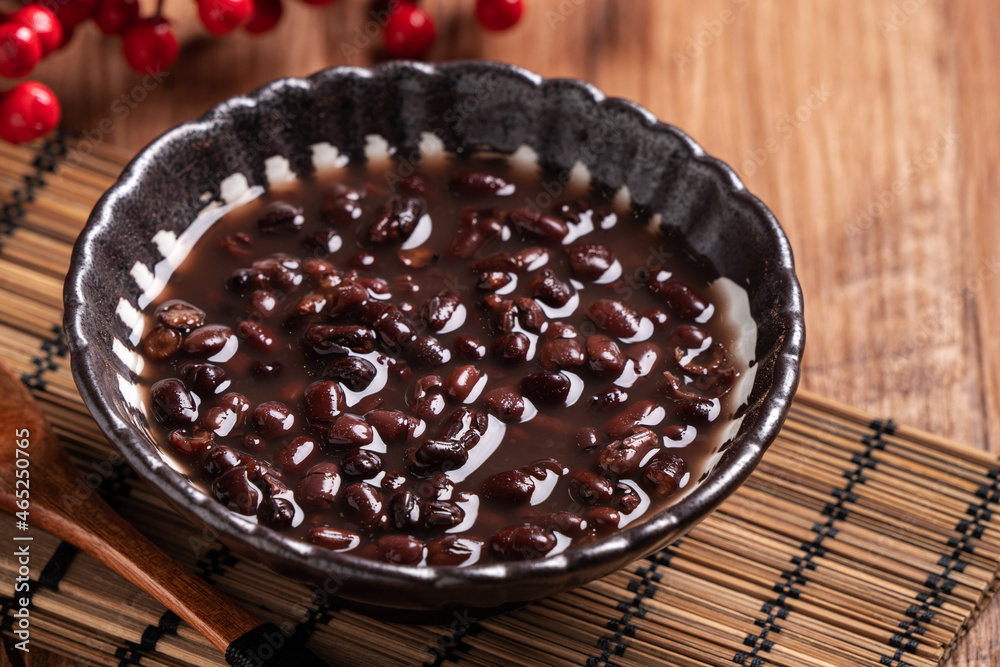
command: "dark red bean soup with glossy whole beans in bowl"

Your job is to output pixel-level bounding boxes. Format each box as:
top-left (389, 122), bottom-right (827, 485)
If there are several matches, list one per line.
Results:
top-left (142, 154), bottom-right (755, 566)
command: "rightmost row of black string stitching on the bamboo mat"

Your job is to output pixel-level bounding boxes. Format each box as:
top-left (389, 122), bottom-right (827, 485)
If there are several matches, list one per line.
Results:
top-left (879, 448), bottom-right (1000, 667)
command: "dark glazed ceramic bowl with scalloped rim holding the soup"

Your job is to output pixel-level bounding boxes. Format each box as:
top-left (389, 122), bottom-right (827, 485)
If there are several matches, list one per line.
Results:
top-left (65, 62), bottom-right (805, 620)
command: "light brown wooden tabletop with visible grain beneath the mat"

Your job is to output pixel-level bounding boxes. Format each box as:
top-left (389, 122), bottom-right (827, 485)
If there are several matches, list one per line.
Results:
top-left (0, 0), bottom-right (1000, 667)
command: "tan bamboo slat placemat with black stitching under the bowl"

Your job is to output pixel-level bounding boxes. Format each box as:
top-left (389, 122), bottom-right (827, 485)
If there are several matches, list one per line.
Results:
top-left (0, 138), bottom-right (1000, 667)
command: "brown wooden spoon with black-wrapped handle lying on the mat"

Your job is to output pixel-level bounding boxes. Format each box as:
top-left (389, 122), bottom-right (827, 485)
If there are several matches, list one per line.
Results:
top-left (0, 363), bottom-right (328, 667)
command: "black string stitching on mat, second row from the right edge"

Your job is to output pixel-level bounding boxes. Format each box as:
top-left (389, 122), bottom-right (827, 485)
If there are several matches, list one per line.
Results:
top-left (733, 419), bottom-right (896, 667)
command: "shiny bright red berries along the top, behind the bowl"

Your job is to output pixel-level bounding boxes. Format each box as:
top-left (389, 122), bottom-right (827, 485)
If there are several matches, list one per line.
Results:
top-left (0, 0), bottom-right (524, 144)
